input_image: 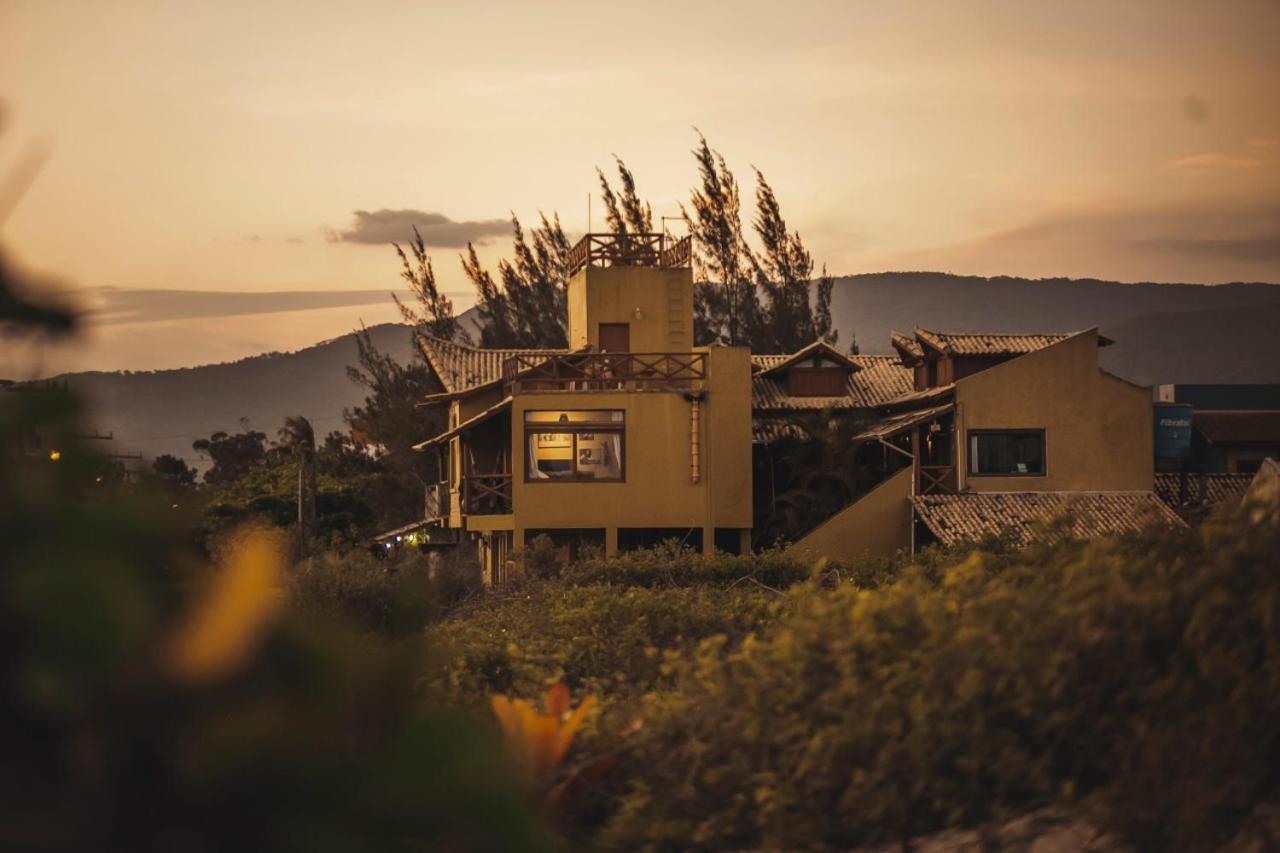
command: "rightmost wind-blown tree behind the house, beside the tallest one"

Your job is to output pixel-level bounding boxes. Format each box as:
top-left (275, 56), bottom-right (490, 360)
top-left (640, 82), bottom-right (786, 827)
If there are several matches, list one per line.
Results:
top-left (749, 169), bottom-right (837, 352)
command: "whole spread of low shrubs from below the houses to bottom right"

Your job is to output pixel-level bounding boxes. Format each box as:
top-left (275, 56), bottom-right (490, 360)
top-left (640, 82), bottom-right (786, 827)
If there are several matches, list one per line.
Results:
top-left (428, 506), bottom-right (1280, 850)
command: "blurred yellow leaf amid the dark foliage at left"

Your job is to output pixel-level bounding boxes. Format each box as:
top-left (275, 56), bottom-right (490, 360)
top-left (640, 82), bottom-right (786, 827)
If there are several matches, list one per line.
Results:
top-left (168, 529), bottom-right (284, 683)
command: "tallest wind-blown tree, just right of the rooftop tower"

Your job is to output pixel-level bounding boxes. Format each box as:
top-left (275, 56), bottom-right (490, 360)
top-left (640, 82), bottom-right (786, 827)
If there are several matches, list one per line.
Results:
top-left (680, 133), bottom-right (759, 346)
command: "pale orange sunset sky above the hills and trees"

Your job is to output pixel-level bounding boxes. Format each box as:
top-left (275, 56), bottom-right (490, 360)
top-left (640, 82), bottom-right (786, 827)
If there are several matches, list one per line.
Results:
top-left (0, 0), bottom-right (1280, 366)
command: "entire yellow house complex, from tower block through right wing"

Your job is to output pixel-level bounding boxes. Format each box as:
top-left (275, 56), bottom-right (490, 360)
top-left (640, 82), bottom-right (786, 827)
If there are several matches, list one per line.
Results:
top-left (404, 234), bottom-right (1178, 583)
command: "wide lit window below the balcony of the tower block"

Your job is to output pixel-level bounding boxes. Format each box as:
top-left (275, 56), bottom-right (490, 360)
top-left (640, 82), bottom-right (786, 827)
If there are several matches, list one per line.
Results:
top-left (525, 410), bottom-right (626, 482)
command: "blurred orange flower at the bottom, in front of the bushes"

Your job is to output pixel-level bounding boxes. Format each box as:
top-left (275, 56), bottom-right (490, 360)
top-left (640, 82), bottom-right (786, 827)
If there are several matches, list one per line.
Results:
top-left (490, 681), bottom-right (595, 784)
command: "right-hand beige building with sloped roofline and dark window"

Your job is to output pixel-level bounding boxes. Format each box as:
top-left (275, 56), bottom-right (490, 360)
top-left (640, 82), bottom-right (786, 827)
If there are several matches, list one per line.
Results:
top-left (797, 329), bottom-right (1181, 558)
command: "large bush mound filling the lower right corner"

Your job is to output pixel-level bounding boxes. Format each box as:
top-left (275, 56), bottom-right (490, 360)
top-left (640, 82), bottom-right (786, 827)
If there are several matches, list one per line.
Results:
top-left (593, 502), bottom-right (1280, 849)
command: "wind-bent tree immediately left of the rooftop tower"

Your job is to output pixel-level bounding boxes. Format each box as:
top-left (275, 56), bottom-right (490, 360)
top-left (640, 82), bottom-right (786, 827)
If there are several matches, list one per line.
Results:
top-left (462, 214), bottom-right (572, 348)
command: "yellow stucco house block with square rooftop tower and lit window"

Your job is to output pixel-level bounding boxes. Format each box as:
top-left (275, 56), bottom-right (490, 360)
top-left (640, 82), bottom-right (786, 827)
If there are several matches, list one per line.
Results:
top-left (421, 234), bottom-right (751, 583)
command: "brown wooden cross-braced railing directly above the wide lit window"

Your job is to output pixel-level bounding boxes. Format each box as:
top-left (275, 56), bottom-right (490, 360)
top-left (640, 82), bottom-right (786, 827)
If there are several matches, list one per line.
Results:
top-left (502, 352), bottom-right (707, 393)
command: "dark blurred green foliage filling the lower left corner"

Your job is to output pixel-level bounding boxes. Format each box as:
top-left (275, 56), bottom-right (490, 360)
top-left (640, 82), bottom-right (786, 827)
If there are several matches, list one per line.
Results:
top-left (0, 392), bottom-right (549, 850)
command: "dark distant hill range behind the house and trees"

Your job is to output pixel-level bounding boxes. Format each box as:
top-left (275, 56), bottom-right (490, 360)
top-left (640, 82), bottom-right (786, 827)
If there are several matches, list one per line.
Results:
top-left (63, 273), bottom-right (1280, 464)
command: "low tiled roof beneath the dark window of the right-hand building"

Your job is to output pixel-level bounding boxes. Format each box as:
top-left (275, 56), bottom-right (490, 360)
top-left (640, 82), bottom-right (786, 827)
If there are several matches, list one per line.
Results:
top-left (911, 492), bottom-right (1184, 546)
